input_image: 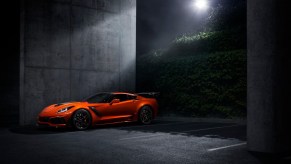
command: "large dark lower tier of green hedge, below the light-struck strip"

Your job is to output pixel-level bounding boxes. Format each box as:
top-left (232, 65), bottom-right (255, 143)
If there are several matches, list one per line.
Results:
top-left (138, 50), bottom-right (246, 117)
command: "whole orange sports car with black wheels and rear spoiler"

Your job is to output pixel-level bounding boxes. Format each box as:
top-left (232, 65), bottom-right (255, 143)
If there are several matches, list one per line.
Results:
top-left (37, 92), bottom-right (158, 130)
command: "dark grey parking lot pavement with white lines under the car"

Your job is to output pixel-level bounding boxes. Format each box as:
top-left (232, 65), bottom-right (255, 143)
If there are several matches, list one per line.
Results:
top-left (0, 118), bottom-right (290, 164)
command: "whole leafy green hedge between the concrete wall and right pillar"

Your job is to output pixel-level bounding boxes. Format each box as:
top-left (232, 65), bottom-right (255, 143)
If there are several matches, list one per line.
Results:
top-left (137, 32), bottom-right (246, 117)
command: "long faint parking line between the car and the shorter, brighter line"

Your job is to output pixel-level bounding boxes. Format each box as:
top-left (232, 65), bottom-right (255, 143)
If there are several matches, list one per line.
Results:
top-left (119, 125), bottom-right (241, 140)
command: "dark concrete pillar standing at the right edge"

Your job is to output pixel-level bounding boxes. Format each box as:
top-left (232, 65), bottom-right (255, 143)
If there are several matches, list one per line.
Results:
top-left (247, 0), bottom-right (291, 154)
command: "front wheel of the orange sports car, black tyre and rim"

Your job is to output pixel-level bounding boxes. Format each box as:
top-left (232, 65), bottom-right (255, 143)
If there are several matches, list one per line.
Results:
top-left (72, 109), bottom-right (92, 130)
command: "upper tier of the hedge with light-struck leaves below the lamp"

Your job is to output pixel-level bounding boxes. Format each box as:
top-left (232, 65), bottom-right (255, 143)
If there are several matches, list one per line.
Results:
top-left (168, 29), bottom-right (246, 56)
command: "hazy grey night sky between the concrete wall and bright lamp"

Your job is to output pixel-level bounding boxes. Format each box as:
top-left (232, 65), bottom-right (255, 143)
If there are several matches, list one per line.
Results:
top-left (137, 0), bottom-right (215, 55)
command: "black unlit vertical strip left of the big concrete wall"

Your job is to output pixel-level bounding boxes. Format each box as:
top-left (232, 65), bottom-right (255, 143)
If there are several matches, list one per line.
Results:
top-left (0, 0), bottom-right (20, 126)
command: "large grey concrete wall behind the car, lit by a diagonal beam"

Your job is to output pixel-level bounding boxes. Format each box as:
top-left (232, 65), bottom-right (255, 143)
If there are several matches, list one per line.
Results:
top-left (20, 0), bottom-right (136, 125)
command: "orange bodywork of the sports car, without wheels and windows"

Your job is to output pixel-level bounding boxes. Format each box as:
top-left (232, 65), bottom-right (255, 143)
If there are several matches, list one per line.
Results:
top-left (37, 92), bottom-right (158, 127)
